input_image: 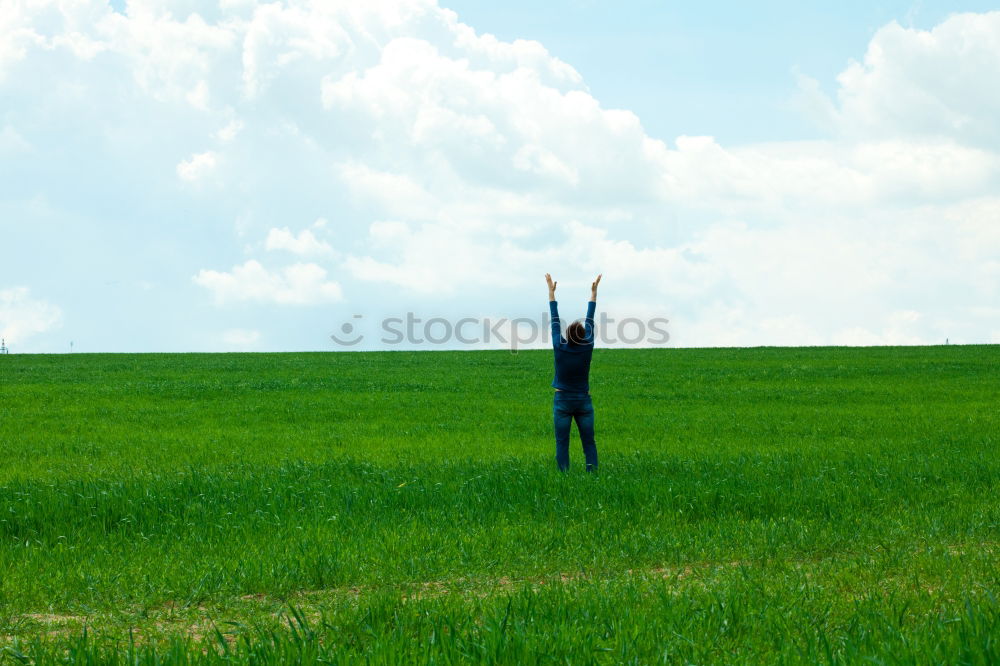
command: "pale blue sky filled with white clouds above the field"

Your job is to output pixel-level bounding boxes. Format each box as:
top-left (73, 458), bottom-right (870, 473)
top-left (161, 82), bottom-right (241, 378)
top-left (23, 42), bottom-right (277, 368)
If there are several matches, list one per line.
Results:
top-left (0, 0), bottom-right (1000, 352)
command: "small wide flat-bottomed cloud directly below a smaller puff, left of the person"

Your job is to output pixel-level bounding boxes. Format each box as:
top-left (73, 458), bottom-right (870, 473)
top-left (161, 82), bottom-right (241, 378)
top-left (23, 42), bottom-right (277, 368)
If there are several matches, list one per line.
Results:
top-left (193, 259), bottom-right (343, 305)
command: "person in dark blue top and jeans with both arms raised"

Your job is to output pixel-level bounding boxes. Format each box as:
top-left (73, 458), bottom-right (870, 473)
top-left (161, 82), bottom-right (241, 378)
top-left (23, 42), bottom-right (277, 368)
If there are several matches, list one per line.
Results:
top-left (545, 273), bottom-right (601, 472)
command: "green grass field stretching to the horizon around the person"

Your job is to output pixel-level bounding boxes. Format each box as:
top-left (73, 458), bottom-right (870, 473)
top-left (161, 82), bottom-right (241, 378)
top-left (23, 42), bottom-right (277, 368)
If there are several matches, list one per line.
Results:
top-left (0, 346), bottom-right (1000, 664)
